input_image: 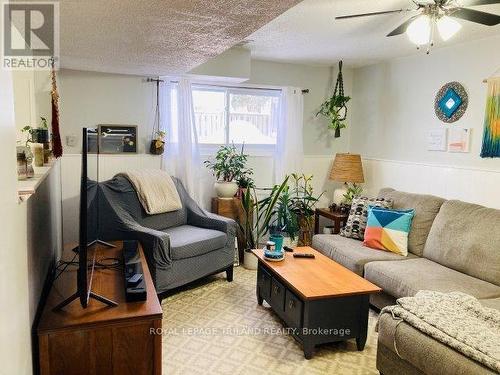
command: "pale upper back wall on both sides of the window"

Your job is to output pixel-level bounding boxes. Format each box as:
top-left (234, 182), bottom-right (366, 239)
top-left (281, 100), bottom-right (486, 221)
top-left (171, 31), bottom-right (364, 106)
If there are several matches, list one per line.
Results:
top-left (55, 60), bottom-right (352, 155)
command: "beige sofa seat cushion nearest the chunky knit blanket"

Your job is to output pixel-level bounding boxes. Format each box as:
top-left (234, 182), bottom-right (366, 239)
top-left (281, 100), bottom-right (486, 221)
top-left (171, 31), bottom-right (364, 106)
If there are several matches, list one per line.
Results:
top-left (365, 258), bottom-right (500, 299)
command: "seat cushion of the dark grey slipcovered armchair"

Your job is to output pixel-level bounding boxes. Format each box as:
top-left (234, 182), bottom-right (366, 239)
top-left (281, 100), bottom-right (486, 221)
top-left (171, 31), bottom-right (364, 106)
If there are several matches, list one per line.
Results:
top-left (164, 225), bottom-right (227, 260)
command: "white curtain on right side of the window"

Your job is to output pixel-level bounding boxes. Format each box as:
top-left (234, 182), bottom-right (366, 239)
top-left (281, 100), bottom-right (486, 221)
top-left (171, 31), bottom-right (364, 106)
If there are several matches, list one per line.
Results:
top-left (274, 87), bottom-right (304, 184)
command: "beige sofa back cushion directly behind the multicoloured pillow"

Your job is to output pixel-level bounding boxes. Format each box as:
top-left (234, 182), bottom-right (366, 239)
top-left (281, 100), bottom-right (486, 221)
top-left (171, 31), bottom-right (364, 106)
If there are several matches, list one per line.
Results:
top-left (379, 188), bottom-right (445, 256)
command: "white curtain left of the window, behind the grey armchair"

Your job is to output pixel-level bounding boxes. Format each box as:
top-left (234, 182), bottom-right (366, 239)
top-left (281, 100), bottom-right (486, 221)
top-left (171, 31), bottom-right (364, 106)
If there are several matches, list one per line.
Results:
top-left (160, 79), bottom-right (203, 203)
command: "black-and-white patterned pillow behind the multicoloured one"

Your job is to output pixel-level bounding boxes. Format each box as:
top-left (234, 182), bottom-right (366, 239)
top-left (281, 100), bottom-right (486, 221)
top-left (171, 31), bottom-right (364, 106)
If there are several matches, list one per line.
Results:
top-left (340, 197), bottom-right (392, 241)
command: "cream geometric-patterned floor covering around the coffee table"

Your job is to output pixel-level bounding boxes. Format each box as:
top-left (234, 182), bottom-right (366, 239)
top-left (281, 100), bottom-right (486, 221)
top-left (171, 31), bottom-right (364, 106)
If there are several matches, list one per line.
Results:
top-left (162, 267), bottom-right (378, 375)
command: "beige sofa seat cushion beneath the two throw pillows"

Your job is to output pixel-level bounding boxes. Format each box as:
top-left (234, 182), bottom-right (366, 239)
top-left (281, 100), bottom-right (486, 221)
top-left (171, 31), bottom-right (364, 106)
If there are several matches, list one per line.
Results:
top-left (312, 234), bottom-right (416, 276)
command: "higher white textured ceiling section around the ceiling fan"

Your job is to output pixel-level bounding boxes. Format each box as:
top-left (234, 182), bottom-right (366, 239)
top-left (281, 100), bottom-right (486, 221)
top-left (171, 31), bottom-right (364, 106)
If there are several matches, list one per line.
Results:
top-left (246, 0), bottom-right (500, 66)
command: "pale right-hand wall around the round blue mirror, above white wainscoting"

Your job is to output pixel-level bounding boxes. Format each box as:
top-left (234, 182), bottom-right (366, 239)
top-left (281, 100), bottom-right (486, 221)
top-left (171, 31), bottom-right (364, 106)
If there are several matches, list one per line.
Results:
top-left (351, 36), bottom-right (500, 170)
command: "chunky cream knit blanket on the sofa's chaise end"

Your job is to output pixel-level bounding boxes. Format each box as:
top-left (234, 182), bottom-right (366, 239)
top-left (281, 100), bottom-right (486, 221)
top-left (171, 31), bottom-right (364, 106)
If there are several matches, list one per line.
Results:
top-left (380, 290), bottom-right (500, 373)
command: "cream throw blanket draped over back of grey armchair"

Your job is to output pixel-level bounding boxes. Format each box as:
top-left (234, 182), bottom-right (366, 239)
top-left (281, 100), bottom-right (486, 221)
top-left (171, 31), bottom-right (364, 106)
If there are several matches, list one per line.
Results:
top-left (117, 169), bottom-right (182, 215)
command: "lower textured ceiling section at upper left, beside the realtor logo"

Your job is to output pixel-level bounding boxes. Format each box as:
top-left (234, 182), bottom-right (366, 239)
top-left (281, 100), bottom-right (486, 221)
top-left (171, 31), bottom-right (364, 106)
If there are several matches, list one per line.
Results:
top-left (60, 0), bottom-right (299, 75)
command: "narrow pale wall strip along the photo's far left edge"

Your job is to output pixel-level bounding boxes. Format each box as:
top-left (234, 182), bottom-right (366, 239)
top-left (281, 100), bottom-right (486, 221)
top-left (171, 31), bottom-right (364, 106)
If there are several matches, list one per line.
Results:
top-left (0, 70), bottom-right (32, 375)
